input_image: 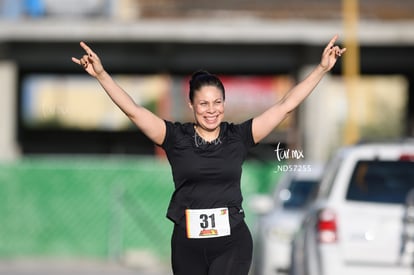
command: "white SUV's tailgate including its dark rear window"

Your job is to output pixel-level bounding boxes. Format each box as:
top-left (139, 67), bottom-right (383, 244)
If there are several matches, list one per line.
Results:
top-left (337, 160), bottom-right (414, 266)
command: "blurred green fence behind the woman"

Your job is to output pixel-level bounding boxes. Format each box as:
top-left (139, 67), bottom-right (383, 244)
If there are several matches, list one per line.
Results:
top-left (0, 157), bottom-right (274, 270)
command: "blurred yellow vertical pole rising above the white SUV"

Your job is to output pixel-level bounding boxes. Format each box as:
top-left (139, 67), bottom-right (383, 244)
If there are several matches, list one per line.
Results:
top-left (342, 0), bottom-right (360, 144)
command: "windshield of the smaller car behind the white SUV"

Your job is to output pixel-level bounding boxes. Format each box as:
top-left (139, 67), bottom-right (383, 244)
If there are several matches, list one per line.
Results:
top-left (281, 180), bottom-right (318, 209)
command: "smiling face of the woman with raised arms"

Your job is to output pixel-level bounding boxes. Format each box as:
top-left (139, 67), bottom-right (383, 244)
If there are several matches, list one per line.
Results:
top-left (190, 86), bottom-right (224, 131)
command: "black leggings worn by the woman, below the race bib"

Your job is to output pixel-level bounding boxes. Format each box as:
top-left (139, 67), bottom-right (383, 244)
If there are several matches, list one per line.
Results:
top-left (171, 221), bottom-right (253, 275)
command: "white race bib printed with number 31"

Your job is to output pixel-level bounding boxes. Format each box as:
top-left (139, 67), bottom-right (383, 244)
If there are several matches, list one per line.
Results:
top-left (185, 207), bottom-right (230, 239)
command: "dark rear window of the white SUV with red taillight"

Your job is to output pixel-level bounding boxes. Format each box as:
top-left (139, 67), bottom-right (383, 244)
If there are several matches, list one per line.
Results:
top-left (346, 161), bottom-right (414, 204)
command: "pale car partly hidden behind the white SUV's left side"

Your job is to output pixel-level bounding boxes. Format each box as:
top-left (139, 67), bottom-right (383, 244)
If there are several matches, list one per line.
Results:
top-left (249, 165), bottom-right (322, 275)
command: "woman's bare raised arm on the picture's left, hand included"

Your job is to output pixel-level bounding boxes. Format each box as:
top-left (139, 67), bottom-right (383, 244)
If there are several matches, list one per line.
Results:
top-left (72, 42), bottom-right (166, 145)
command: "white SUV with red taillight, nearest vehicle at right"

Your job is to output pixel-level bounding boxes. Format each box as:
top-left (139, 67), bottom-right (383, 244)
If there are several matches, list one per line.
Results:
top-left (291, 142), bottom-right (414, 275)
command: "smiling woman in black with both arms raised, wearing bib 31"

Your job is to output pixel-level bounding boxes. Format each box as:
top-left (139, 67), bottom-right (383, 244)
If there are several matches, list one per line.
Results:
top-left (72, 36), bottom-right (346, 275)
